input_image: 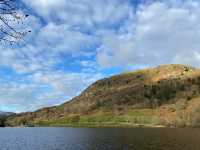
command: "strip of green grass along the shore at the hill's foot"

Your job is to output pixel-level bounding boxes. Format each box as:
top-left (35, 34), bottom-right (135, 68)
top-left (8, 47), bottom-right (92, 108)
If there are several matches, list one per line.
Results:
top-left (34, 111), bottom-right (159, 127)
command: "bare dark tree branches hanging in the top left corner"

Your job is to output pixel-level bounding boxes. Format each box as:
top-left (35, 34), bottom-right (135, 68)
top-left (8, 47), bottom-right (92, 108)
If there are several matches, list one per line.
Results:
top-left (0, 0), bottom-right (31, 44)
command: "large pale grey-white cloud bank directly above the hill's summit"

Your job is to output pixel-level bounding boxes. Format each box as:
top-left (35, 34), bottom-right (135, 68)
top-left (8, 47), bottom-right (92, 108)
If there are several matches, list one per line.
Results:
top-left (97, 1), bottom-right (200, 67)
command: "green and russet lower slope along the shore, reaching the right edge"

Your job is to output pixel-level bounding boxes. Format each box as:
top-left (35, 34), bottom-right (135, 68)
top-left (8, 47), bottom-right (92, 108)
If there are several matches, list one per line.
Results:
top-left (32, 98), bottom-right (200, 127)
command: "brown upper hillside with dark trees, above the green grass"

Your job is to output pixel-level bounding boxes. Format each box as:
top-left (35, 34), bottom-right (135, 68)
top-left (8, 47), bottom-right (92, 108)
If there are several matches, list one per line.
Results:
top-left (7, 65), bottom-right (200, 125)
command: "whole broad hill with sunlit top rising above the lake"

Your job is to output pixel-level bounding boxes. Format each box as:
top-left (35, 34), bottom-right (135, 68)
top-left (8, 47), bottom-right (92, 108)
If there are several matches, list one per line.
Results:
top-left (6, 65), bottom-right (200, 126)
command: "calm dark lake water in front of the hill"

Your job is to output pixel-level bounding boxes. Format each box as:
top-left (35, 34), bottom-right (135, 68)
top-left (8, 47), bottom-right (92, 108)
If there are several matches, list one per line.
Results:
top-left (0, 128), bottom-right (200, 150)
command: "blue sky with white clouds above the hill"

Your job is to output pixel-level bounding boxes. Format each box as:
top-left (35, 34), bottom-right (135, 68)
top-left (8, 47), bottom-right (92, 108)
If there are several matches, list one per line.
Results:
top-left (0, 0), bottom-right (200, 112)
